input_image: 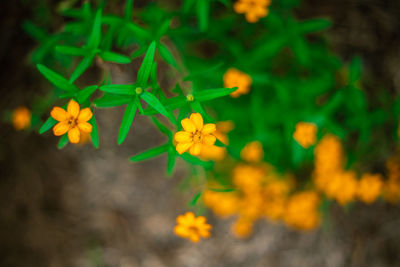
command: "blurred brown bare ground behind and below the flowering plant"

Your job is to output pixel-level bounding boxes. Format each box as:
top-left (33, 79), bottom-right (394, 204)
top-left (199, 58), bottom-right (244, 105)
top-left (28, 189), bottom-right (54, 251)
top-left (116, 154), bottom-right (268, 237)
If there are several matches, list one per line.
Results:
top-left (0, 0), bottom-right (400, 267)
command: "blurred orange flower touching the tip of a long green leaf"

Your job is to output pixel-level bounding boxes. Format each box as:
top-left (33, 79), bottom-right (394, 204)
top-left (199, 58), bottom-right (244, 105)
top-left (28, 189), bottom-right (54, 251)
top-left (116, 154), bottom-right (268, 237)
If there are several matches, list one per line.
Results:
top-left (223, 68), bottom-right (252, 97)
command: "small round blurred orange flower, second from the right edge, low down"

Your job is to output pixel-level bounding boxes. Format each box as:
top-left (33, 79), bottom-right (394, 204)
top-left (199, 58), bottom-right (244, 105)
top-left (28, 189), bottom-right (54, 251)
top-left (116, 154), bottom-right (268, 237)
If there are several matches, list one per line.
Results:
top-left (357, 173), bottom-right (383, 204)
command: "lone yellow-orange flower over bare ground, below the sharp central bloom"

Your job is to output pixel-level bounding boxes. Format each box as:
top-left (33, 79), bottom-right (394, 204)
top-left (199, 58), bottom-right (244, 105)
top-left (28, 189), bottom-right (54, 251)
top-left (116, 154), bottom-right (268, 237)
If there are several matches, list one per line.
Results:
top-left (174, 212), bottom-right (211, 242)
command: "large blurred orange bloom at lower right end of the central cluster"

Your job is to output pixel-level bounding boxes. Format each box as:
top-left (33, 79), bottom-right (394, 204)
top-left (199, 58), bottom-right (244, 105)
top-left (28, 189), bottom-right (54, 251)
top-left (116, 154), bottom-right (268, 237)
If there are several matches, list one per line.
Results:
top-left (284, 191), bottom-right (320, 230)
